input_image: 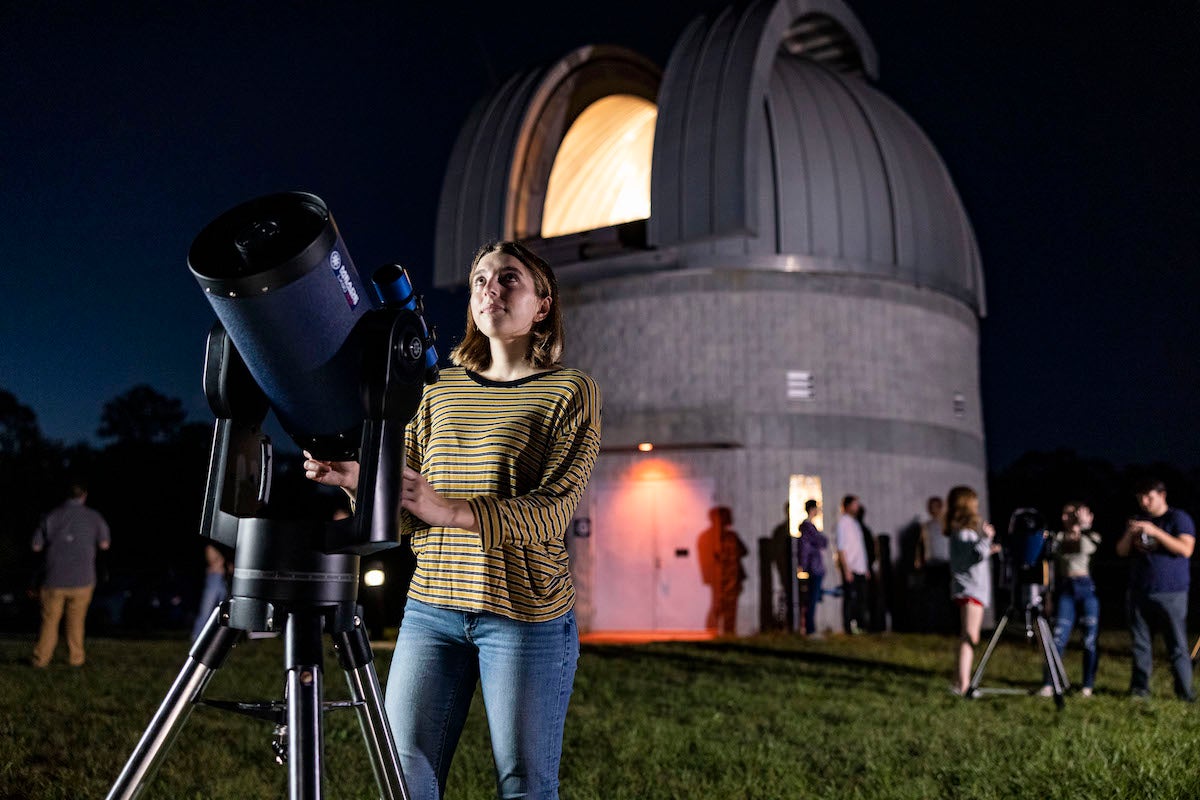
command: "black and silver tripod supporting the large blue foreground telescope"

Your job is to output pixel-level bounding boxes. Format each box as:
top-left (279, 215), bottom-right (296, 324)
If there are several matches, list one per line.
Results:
top-left (108, 521), bottom-right (409, 800)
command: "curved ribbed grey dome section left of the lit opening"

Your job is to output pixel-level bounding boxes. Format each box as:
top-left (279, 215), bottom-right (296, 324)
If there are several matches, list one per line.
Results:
top-left (433, 70), bottom-right (542, 288)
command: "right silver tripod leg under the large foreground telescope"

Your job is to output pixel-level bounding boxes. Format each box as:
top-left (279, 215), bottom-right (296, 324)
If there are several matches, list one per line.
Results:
top-left (334, 615), bottom-right (409, 800)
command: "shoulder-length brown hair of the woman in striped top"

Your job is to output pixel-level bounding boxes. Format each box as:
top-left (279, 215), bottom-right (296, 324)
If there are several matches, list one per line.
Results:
top-left (450, 241), bottom-right (563, 372)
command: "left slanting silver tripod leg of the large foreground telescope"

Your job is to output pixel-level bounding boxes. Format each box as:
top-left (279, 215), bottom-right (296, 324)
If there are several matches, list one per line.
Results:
top-left (108, 603), bottom-right (241, 800)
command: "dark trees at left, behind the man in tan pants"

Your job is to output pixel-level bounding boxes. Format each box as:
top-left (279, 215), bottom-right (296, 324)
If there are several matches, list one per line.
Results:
top-left (0, 385), bottom-right (329, 624)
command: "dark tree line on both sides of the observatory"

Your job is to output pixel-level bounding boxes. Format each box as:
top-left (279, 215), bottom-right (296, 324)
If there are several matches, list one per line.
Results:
top-left (0, 385), bottom-right (1200, 625)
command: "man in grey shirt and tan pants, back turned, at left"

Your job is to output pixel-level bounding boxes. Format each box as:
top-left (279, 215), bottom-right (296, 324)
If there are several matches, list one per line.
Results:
top-left (30, 483), bottom-right (110, 667)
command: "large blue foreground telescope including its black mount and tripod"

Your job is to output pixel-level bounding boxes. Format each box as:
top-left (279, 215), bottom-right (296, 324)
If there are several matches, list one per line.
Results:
top-left (108, 192), bottom-right (437, 800)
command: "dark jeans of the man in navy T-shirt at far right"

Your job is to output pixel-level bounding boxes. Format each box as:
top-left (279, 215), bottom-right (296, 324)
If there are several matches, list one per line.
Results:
top-left (1129, 590), bottom-right (1192, 699)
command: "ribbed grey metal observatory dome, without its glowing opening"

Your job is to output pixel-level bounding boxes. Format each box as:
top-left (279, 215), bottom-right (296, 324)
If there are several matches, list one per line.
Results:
top-left (436, 0), bottom-right (984, 313)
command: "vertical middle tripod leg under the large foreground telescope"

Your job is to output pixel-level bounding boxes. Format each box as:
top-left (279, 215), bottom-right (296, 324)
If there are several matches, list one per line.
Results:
top-left (283, 612), bottom-right (324, 800)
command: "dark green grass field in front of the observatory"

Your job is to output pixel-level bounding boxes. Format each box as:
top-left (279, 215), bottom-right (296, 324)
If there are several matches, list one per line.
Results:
top-left (0, 632), bottom-right (1200, 800)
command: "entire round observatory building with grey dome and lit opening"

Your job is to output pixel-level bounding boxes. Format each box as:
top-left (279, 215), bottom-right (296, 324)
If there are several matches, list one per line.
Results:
top-left (434, 0), bottom-right (985, 636)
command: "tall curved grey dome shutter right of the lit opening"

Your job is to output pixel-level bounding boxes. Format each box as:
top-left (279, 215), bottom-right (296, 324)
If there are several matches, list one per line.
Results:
top-left (647, 0), bottom-right (877, 246)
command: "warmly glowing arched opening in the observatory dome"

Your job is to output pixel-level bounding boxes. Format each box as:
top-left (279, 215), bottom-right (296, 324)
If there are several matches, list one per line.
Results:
top-left (541, 95), bottom-right (659, 239)
